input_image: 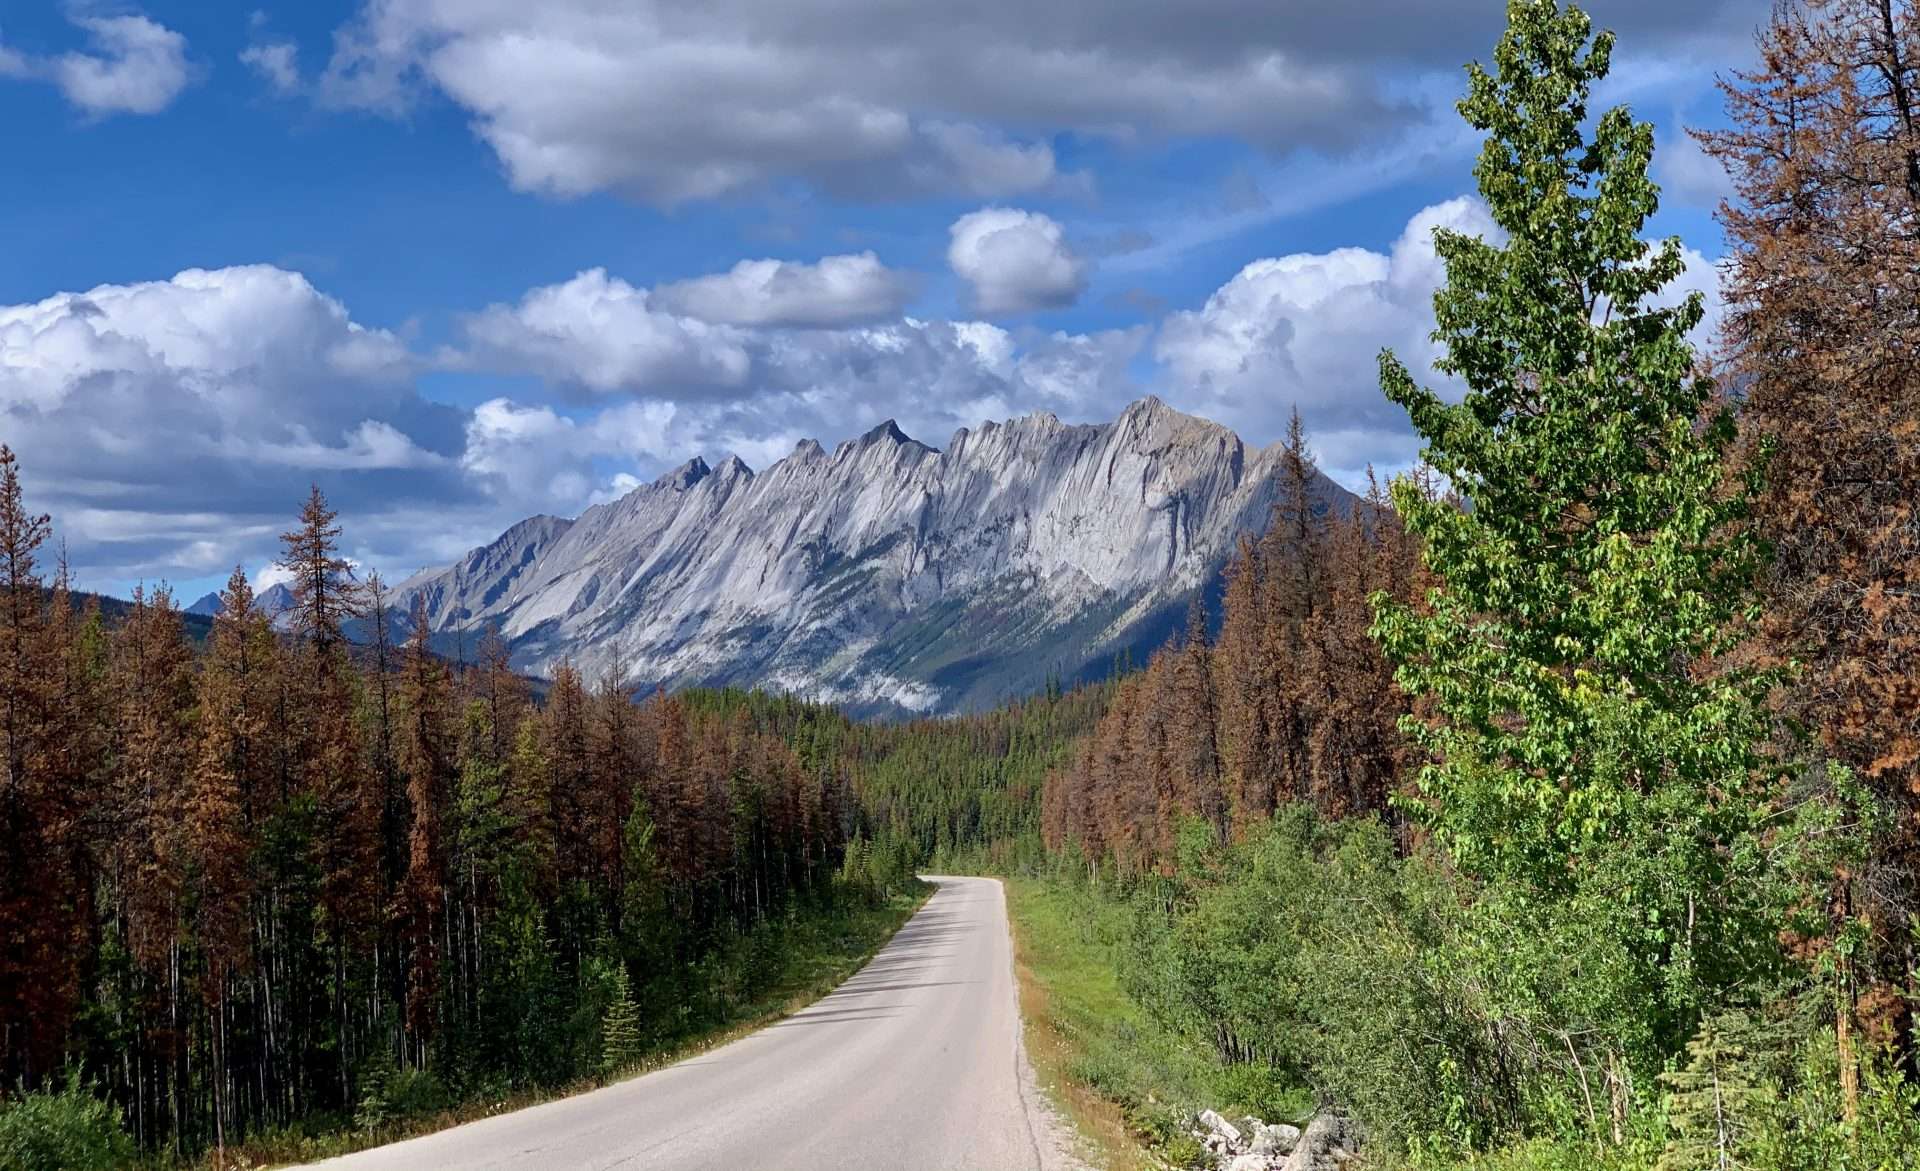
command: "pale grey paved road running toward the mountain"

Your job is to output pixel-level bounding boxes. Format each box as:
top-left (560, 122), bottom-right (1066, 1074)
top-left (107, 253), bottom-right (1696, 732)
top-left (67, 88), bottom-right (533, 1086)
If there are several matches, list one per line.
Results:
top-left (305, 877), bottom-right (1068, 1171)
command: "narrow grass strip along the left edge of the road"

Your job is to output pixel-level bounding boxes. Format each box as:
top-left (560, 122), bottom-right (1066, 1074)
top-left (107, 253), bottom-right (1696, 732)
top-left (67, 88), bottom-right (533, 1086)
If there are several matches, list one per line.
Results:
top-left (174, 883), bottom-right (933, 1171)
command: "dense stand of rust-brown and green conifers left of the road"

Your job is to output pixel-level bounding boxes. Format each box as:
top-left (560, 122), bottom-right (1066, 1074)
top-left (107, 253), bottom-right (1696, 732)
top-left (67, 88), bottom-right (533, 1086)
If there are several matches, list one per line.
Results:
top-left (0, 466), bottom-right (871, 1152)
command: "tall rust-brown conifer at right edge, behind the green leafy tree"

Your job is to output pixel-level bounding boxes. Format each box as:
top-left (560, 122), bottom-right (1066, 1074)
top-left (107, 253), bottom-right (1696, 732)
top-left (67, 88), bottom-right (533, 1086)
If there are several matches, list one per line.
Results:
top-left (1701, 0), bottom-right (1920, 1044)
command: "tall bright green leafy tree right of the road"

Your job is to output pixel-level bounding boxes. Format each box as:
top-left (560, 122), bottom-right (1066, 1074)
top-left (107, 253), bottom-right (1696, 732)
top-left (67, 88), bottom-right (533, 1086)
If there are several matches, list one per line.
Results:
top-left (1375, 0), bottom-right (1778, 1135)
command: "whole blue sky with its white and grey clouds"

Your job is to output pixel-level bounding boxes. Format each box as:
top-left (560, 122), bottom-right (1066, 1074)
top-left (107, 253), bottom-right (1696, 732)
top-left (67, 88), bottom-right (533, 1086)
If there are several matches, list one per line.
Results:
top-left (0, 0), bottom-right (1766, 595)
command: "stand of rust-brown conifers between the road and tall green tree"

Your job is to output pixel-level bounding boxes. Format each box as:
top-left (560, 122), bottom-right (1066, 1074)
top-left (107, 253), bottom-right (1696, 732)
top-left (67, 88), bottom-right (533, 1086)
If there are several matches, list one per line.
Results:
top-left (1043, 415), bottom-right (1421, 875)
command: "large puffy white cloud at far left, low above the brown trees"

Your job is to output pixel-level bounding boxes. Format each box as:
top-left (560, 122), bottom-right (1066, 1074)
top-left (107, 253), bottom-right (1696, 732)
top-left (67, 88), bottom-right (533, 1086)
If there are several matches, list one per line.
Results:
top-left (0, 265), bottom-right (459, 578)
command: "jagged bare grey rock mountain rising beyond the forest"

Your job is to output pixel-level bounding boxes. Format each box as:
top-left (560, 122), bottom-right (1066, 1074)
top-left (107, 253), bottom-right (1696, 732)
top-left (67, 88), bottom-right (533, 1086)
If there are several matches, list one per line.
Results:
top-left (396, 397), bottom-right (1350, 714)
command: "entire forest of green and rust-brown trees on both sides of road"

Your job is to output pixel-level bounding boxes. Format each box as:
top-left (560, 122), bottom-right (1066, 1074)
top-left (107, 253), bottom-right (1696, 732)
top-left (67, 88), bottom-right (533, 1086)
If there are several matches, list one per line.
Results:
top-left (11, 0), bottom-right (1920, 1171)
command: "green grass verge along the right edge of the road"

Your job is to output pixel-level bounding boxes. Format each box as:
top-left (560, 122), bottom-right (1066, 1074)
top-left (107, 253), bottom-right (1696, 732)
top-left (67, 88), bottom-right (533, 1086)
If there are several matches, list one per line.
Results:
top-left (1004, 877), bottom-right (1282, 1171)
